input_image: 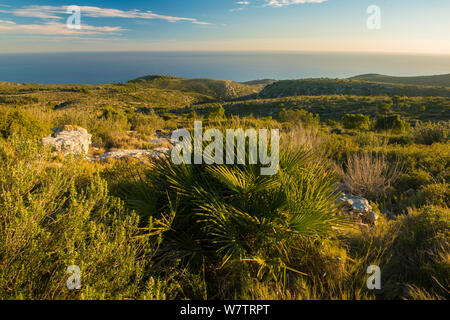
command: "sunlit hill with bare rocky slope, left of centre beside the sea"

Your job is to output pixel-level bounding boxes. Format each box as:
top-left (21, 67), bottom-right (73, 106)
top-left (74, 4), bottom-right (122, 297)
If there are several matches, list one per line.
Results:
top-left (129, 75), bottom-right (265, 100)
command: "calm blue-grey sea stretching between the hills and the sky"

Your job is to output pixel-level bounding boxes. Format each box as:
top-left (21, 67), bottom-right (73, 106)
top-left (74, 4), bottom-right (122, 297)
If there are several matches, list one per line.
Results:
top-left (0, 52), bottom-right (450, 84)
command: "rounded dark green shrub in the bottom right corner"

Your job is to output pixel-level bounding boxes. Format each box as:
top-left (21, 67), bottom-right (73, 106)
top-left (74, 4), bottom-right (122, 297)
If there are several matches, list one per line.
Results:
top-left (380, 207), bottom-right (450, 299)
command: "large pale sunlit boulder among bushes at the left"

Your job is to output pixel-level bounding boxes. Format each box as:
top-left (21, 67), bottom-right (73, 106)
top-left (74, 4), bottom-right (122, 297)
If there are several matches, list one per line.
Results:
top-left (41, 125), bottom-right (92, 155)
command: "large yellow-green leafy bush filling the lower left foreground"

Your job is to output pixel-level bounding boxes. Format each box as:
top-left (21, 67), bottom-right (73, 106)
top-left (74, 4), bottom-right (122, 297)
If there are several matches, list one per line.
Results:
top-left (0, 138), bottom-right (156, 299)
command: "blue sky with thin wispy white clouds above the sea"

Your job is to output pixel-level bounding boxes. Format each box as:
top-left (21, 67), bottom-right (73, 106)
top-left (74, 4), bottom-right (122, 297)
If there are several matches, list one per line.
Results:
top-left (0, 0), bottom-right (450, 55)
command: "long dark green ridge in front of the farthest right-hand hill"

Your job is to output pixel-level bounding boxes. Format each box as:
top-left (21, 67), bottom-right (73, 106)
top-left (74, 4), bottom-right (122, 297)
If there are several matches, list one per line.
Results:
top-left (259, 78), bottom-right (450, 98)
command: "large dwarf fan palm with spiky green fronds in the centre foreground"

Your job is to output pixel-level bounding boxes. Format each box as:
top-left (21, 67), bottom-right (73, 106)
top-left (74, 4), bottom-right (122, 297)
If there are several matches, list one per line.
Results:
top-left (125, 130), bottom-right (342, 284)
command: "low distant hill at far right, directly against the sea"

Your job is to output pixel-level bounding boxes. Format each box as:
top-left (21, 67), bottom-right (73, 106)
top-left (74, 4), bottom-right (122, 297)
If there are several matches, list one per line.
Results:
top-left (349, 73), bottom-right (450, 87)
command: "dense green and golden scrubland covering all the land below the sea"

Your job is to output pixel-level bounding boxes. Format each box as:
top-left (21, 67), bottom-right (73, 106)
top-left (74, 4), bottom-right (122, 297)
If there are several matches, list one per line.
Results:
top-left (0, 76), bottom-right (450, 299)
